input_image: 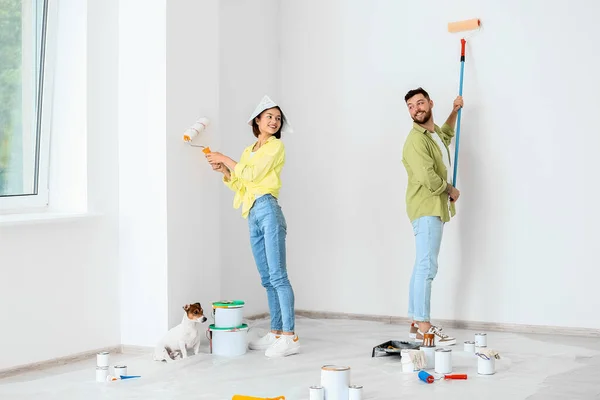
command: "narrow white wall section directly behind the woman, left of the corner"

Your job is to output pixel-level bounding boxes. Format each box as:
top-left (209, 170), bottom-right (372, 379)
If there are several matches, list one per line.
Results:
top-left (217, 0), bottom-right (280, 315)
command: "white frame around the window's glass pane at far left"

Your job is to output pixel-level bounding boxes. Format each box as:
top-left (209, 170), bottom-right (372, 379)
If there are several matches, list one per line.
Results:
top-left (0, 0), bottom-right (57, 214)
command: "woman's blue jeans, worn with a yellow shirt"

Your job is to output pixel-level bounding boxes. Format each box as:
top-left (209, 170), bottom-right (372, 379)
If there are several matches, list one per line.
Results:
top-left (248, 194), bottom-right (295, 332)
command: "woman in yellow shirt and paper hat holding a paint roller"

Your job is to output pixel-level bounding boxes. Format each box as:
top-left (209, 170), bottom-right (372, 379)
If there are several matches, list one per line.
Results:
top-left (206, 96), bottom-right (300, 357)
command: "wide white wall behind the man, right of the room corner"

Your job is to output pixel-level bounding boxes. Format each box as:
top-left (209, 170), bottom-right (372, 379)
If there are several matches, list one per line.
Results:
top-left (281, 0), bottom-right (600, 328)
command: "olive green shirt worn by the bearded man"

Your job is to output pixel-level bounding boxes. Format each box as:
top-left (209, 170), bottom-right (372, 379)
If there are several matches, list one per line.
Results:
top-left (402, 122), bottom-right (456, 222)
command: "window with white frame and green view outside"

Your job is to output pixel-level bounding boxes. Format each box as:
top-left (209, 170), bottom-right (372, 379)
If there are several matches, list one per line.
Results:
top-left (0, 0), bottom-right (51, 211)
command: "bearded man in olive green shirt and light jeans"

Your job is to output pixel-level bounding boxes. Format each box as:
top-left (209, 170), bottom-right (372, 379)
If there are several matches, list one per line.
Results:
top-left (402, 88), bottom-right (463, 346)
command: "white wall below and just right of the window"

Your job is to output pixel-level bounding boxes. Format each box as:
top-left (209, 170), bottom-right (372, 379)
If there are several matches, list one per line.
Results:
top-left (0, 0), bottom-right (121, 370)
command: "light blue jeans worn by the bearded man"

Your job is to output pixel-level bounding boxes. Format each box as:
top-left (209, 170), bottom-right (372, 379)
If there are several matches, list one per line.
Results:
top-left (408, 217), bottom-right (444, 322)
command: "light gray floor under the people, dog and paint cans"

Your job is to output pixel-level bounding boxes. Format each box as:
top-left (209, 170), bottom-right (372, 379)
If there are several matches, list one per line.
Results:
top-left (0, 318), bottom-right (600, 400)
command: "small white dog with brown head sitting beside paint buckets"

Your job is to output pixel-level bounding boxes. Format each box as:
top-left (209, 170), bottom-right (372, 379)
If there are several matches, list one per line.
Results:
top-left (154, 303), bottom-right (206, 362)
